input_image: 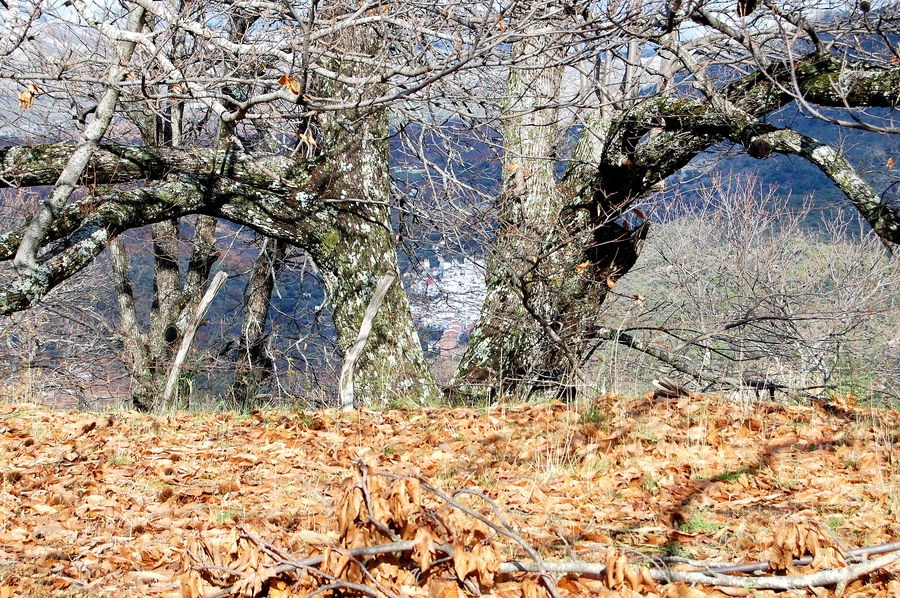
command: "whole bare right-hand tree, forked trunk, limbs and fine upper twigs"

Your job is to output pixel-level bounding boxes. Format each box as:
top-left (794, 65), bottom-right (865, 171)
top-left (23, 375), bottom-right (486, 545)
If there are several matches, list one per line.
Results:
top-left (453, 2), bottom-right (900, 404)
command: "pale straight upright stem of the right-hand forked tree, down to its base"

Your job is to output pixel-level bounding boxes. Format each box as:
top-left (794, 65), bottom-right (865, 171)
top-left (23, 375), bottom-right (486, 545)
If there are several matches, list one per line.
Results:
top-left (450, 23), bottom-right (574, 402)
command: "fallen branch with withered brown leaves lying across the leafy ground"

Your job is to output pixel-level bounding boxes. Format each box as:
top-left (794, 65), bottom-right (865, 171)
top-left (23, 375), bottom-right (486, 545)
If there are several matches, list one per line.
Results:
top-left (185, 463), bottom-right (900, 598)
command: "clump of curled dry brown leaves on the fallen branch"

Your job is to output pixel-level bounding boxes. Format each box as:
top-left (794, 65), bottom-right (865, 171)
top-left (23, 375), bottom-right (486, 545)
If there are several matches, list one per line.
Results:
top-left (187, 461), bottom-right (500, 598)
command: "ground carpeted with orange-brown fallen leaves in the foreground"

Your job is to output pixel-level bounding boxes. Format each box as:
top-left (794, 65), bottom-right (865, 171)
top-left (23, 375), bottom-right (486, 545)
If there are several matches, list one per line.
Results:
top-left (0, 396), bottom-right (900, 598)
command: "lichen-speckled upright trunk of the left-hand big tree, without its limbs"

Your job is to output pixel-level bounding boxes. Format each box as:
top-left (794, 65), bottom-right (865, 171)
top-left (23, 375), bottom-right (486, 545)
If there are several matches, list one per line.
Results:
top-left (309, 110), bottom-right (439, 407)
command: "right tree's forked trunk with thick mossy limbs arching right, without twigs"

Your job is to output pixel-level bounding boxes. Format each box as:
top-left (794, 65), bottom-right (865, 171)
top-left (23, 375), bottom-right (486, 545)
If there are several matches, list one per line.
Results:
top-left (449, 49), bottom-right (900, 402)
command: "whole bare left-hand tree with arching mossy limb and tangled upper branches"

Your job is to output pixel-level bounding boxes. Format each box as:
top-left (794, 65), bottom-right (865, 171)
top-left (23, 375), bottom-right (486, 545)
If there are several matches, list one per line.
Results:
top-left (5, 2), bottom-right (510, 408)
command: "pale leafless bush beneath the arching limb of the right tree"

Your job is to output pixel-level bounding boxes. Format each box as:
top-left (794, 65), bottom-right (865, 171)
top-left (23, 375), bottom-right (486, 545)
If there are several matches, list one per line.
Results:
top-left (600, 177), bottom-right (900, 408)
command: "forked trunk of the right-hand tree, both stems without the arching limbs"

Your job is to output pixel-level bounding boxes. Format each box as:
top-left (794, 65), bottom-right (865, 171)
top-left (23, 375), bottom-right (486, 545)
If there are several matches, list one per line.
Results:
top-left (448, 15), bottom-right (645, 402)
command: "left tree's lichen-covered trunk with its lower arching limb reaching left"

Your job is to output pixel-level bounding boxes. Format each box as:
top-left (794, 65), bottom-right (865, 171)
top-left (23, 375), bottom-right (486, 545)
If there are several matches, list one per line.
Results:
top-left (0, 152), bottom-right (437, 406)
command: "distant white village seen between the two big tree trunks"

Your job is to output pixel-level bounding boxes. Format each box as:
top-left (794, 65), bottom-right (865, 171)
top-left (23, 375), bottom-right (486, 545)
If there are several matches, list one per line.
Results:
top-left (405, 257), bottom-right (486, 359)
